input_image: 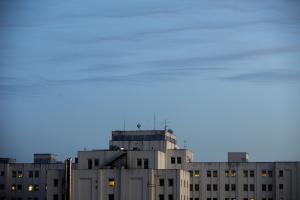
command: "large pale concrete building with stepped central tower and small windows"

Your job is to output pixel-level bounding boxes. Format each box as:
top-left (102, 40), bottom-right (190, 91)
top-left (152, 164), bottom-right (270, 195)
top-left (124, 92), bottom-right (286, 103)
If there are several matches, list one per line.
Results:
top-left (0, 130), bottom-right (300, 200)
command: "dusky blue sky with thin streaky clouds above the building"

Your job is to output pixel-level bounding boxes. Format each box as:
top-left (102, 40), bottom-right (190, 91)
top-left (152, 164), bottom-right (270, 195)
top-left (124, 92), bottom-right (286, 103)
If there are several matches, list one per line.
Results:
top-left (0, 0), bottom-right (300, 162)
